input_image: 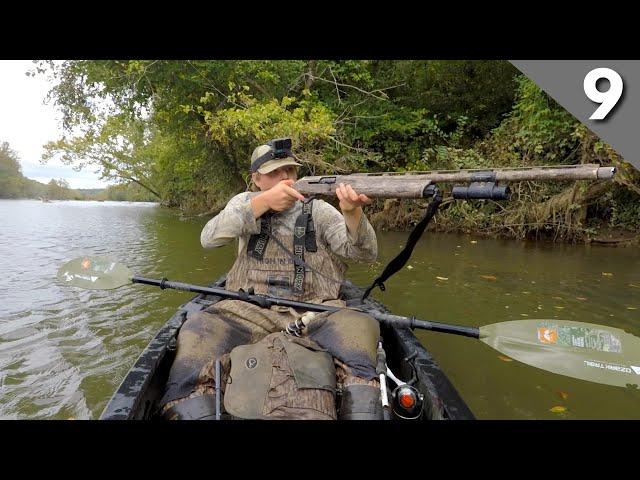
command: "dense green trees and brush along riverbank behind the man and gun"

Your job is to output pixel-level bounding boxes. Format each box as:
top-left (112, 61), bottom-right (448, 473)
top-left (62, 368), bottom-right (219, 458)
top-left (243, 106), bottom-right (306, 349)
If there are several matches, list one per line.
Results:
top-left (33, 60), bottom-right (640, 241)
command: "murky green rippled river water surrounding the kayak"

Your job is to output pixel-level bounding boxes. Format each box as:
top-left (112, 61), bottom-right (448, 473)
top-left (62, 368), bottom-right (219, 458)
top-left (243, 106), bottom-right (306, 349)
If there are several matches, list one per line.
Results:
top-left (0, 200), bottom-right (640, 419)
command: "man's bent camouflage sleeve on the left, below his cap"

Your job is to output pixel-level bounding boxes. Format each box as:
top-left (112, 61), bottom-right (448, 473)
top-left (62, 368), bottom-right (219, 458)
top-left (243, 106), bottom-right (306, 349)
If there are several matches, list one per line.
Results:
top-left (200, 192), bottom-right (260, 248)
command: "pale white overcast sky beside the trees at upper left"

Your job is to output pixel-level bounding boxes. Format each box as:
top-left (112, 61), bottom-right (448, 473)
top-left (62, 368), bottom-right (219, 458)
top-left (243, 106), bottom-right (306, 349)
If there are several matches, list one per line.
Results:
top-left (0, 60), bottom-right (108, 188)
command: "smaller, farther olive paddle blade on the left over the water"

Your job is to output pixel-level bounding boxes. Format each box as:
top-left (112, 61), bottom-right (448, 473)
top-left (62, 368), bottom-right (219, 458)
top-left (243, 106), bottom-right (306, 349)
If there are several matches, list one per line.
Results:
top-left (58, 257), bottom-right (133, 290)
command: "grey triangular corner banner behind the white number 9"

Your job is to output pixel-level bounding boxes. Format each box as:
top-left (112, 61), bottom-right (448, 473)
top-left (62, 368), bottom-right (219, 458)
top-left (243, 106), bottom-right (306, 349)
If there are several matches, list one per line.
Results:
top-left (511, 60), bottom-right (640, 170)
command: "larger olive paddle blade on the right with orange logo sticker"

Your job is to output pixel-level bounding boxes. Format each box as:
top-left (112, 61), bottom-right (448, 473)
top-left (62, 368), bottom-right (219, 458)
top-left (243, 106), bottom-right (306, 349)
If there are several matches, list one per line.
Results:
top-left (480, 320), bottom-right (640, 388)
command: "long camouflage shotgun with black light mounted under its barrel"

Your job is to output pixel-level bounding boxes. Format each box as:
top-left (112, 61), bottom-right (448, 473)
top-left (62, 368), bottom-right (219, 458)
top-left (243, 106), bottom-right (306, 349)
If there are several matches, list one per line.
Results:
top-left (293, 164), bottom-right (616, 200)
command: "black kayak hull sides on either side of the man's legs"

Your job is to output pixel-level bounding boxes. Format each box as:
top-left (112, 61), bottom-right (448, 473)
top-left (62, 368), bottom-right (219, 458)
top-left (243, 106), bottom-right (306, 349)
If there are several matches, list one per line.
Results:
top-left (100, 277), bottom-right (475, 420)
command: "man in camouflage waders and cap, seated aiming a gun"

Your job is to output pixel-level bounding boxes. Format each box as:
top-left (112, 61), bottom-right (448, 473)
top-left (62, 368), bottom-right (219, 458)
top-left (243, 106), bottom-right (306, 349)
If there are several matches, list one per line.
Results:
top-left (161, 139), bottom-right (382, 420)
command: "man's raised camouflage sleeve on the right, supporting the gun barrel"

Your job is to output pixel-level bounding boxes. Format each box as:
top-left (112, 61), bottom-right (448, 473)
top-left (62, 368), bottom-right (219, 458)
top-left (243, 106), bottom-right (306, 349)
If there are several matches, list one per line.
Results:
top-left (313, 200), bottom-right (378, 263)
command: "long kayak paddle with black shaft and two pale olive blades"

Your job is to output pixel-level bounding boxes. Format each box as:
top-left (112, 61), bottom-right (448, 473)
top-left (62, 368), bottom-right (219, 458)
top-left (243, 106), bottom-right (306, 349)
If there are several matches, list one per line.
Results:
top-left (58, 256), bottom-right (640, 388)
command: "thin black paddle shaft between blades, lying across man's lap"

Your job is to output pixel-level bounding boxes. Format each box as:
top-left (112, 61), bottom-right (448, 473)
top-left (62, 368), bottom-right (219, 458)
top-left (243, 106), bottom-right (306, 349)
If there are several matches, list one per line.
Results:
top-left (131, 276), bottom-right (480, 338)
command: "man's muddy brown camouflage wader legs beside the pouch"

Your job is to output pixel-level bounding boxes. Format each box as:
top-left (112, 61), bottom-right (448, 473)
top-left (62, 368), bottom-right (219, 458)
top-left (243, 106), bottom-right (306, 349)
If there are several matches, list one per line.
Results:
top-left (161, 300), bottom-right (380, 418)
